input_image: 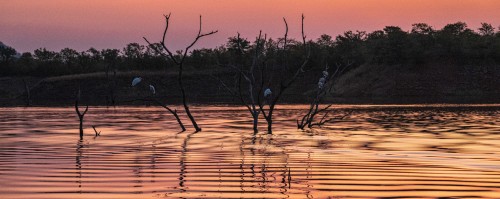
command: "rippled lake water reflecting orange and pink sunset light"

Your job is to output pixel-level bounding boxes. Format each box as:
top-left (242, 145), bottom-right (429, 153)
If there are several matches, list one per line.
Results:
top-left (0, 105), bottom-right (500, 199)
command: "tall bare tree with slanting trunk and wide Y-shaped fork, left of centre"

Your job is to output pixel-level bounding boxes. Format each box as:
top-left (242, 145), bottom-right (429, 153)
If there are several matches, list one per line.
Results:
top-left (144, 14), bottom-right (218, 132)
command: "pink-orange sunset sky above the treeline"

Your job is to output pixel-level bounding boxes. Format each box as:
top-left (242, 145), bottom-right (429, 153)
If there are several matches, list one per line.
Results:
top-left (0, 0), bottom-right (500, 51)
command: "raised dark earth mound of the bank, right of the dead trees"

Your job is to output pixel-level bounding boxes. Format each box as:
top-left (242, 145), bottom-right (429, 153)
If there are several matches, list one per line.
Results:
top-left (330, 64), bottom-right (500, 104)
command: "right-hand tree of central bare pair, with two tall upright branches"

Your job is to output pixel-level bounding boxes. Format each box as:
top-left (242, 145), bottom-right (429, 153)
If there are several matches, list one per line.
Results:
top-left (258, 15), bottom-right (311, 134)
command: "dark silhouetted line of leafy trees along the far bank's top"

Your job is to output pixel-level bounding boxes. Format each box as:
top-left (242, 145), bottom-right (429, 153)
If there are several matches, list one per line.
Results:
top-left (0, 22), bottom-right (500, 77)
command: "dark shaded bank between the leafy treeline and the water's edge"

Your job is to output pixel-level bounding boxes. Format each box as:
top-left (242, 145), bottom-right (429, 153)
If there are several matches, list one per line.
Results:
top-left (0, 65), bottom-right (500, 106)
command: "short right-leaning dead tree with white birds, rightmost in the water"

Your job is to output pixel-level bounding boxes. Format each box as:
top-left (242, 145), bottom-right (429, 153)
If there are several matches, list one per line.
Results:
top-left (297, 62), bottom-right (353, 130)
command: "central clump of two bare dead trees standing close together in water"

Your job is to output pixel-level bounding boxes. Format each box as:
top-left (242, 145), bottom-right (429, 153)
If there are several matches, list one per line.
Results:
top-left (219, 16), bottom-right (311, 134)
